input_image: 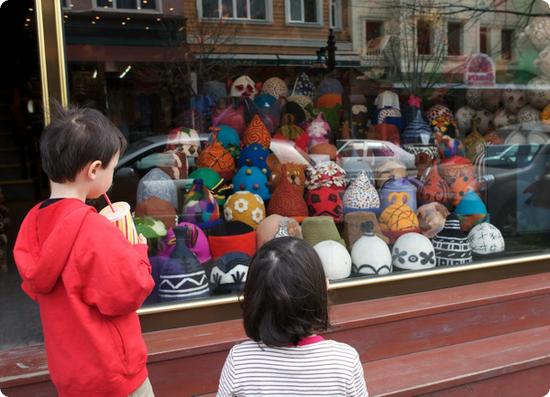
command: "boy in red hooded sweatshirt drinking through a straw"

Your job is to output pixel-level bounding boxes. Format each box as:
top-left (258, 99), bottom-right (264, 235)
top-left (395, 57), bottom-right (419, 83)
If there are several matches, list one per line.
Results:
top-left (14, 105), bottom-right (154, 397)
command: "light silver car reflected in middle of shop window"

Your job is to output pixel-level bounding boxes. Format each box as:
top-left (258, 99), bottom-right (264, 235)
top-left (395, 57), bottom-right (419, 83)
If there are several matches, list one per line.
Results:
top-left (337, 139), bottom-right (416, 179)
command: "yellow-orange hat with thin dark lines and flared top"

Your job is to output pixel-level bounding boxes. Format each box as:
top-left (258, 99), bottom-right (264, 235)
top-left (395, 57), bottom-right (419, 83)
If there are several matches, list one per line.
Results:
top-left (380, 192), bottom-right (420, 242)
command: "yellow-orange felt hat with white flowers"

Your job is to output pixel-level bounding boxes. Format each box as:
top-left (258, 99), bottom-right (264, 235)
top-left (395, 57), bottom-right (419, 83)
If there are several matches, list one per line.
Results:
top-left (223, 191), bottom-right (266, 229)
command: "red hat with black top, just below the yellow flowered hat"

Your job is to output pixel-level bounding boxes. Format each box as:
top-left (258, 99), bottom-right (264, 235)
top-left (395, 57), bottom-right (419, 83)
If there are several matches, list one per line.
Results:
top-left (208, 221), bottom-right (256, 260)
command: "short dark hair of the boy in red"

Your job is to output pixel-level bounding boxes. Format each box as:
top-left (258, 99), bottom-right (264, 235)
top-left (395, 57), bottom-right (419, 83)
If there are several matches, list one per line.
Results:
top-left (40, 106), bottom-right (127, 183)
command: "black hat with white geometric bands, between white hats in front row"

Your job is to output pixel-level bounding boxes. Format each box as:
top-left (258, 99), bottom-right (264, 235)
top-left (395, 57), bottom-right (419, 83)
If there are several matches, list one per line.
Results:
top-left (432, 214), bottom-right (472, 266)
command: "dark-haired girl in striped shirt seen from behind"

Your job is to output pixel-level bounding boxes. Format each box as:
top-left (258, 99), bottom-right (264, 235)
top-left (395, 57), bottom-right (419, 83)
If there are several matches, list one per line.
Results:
top-left (217, 237), bottom-right (368, 397)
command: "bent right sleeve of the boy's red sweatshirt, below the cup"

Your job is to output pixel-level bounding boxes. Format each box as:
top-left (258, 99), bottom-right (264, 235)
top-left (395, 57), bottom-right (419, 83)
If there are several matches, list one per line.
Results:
top-left (76, 213), bottom-right (155, 316)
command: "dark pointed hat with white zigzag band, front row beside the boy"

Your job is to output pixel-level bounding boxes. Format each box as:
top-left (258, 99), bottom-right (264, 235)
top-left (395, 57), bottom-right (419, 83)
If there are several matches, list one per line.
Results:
top-left (154, 226), bottom-right (210, 301)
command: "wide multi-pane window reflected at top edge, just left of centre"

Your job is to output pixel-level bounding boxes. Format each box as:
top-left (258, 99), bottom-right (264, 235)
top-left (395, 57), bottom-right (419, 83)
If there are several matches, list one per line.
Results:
top-left (203, 0), bottom-right (268, 20)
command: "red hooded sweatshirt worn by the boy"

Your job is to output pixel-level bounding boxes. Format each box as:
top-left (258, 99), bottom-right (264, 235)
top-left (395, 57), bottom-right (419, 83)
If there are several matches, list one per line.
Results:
top-left (14, 198), bottom-right (154, 397)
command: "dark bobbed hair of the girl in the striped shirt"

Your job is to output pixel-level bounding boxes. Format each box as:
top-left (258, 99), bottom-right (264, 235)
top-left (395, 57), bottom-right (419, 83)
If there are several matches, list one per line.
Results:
top-left (242, 237), bottom-right (330, 346)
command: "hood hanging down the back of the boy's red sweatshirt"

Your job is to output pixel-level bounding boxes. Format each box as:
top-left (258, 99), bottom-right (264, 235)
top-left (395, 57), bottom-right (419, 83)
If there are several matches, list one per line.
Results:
top-left (13, 198), bottom-right (95, 294)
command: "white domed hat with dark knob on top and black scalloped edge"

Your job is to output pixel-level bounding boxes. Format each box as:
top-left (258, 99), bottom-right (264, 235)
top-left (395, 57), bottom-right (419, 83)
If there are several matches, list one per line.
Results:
top-left (351, 222), bottom-right (392, 276)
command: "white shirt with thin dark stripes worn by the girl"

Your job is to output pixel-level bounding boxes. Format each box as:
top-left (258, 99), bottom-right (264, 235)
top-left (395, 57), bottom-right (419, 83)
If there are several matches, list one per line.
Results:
top-left (217, 338), bottom-right (368, 397)
